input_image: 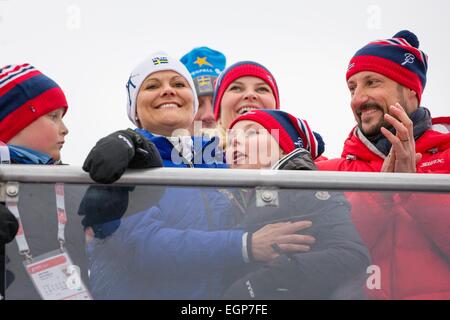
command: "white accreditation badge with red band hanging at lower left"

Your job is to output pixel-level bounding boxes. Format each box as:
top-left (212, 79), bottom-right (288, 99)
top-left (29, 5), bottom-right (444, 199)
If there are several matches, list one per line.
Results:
top-left (24, 249), bottom-right (92, 300)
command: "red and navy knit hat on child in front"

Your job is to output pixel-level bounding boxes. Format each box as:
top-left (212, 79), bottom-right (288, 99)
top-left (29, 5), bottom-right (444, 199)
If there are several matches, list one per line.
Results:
top-left (229, 109), bottom-right (325, 159)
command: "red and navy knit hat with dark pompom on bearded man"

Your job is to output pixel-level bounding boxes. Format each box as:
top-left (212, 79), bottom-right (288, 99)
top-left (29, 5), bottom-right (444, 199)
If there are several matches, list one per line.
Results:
top-left (346, 30), bottom-right (428, 104)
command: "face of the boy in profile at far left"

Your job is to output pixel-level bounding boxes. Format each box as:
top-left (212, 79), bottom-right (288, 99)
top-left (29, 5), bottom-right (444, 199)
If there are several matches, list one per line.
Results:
top-left (8, 108), bottom-right (69, 161)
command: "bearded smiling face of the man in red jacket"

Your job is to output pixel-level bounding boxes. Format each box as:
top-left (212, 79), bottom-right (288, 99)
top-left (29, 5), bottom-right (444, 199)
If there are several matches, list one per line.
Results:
top-left (347, 71), bottom-right (410, 136)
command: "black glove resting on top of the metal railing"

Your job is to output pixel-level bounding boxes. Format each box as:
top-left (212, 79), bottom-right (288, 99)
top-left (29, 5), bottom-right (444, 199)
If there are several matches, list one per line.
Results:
top-left (83, 129), bottom-right (162, 184)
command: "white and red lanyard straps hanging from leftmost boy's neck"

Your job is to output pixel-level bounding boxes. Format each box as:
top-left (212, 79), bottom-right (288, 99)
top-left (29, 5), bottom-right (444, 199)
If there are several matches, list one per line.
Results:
top-left (0, 141), bottom-right (67, 260)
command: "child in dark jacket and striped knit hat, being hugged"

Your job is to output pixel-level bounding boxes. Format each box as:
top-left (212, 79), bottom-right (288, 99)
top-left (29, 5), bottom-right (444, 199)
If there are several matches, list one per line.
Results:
top-left (224, 110), bottom-right (370, 299)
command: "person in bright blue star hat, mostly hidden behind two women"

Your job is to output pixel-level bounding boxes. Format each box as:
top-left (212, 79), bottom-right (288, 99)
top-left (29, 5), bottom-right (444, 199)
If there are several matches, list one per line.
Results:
top-left (180, 47), bottom-right (226, 132)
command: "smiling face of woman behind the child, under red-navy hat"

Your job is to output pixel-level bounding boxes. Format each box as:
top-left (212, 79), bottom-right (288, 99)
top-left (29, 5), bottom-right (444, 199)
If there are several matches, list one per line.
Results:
top-left (220, 77), bottom-right (276, 129)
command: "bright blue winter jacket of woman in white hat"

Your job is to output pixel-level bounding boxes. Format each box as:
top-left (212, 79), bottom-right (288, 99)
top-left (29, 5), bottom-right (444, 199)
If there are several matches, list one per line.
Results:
top-left (88, 130), bottom-right (245, 299)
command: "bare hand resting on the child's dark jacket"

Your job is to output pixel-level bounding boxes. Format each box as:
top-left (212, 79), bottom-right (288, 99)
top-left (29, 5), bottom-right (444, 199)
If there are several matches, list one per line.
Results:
top-left (251, 221), bottom-right (315, 262)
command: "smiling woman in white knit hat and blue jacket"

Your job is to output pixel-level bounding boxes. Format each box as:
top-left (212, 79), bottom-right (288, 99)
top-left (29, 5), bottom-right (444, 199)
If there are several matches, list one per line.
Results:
top-left (83, 53), bottom-right (305, 299)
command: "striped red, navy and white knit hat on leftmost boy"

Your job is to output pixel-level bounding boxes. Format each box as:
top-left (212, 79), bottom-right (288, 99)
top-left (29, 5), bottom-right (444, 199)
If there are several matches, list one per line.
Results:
top-left (0, 64), bottom-right (67, 142)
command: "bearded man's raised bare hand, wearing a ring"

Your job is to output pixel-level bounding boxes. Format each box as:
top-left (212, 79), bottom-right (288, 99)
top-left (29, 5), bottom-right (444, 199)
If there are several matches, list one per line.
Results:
top-left (381, 103), bottom-right (422, 173)
